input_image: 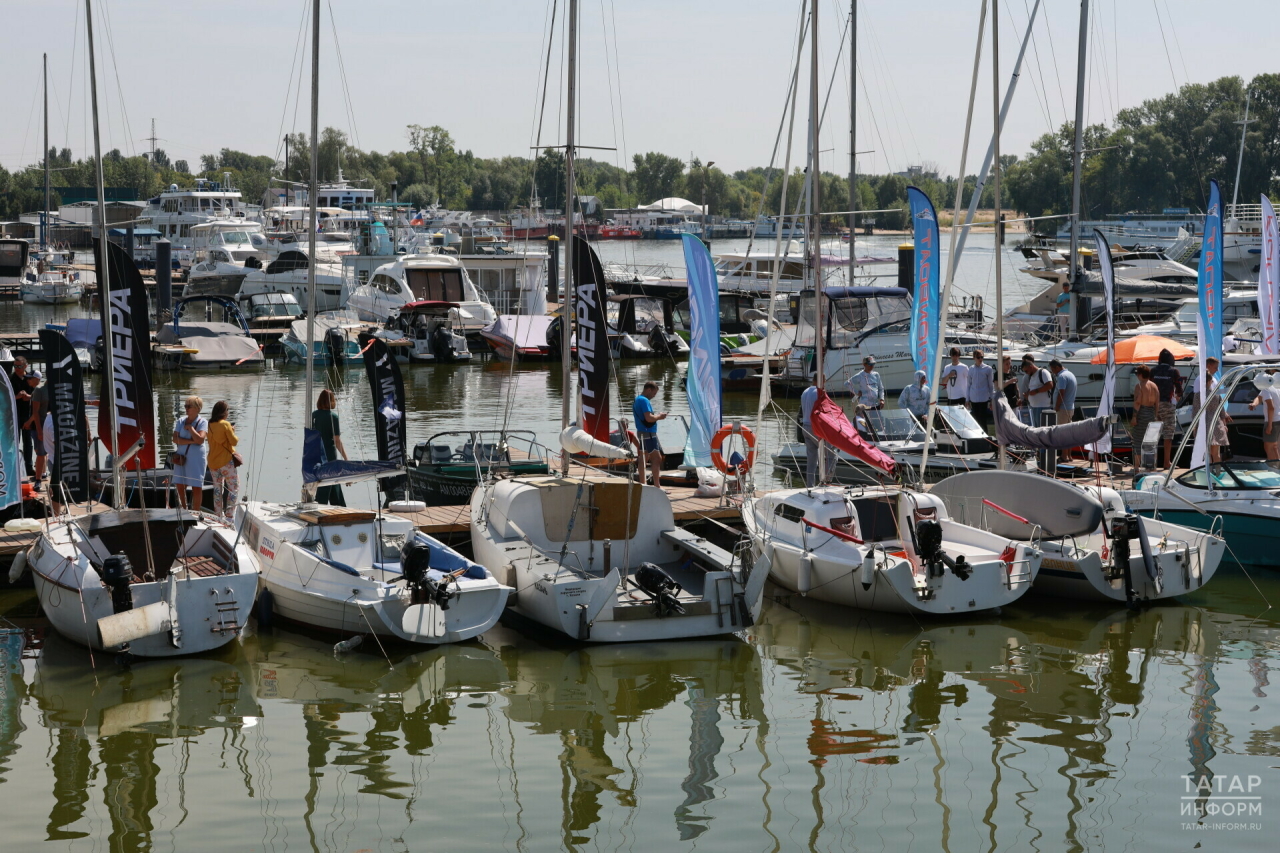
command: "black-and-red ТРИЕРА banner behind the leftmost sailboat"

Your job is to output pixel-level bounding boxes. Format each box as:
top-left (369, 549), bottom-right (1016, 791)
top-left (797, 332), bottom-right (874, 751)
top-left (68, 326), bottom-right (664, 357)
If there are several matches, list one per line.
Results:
top-left (93, 240), bottom-right (156, 467)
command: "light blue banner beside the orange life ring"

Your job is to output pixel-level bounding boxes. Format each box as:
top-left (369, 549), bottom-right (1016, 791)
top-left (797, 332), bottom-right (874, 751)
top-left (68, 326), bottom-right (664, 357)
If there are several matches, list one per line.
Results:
top-left (682, 234), bottom-right (721, 467)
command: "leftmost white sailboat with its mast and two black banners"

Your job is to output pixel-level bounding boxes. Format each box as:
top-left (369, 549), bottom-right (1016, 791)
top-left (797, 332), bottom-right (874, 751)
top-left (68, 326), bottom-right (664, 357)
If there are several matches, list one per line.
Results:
top-left (19, 0), bottom-right (257, 657)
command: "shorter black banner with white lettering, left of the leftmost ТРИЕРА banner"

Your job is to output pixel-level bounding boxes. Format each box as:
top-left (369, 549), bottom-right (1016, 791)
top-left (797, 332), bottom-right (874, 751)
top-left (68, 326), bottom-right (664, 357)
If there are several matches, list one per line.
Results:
top-left (40, 329), bottom-right (90, 503)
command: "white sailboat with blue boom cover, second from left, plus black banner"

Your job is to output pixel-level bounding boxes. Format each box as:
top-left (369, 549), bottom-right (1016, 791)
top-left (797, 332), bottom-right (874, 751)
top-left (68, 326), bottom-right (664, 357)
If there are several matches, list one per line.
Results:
top-left (236, 0), bottom-right (511, 644)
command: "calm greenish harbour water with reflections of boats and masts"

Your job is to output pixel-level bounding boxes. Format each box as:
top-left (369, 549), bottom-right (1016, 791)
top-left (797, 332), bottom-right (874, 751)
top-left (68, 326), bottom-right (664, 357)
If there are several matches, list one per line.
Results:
top-left (0, 235), bottom-right (1280, 853)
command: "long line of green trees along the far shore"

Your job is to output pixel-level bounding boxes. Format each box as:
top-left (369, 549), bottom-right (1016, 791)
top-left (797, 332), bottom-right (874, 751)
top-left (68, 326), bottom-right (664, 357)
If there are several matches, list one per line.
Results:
top-left (0, 74), bottom-right (1280, 229)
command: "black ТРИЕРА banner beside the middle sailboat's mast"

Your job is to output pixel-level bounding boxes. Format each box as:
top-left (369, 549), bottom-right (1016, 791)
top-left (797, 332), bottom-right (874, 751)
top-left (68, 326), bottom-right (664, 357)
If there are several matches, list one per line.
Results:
top-left (571, 240), bottom-right (609, 443)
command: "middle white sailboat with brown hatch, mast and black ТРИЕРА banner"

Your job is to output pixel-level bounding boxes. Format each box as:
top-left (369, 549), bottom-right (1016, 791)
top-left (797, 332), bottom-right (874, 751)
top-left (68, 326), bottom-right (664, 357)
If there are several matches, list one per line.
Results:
top-left (470, 0), bottom-right (764, 643)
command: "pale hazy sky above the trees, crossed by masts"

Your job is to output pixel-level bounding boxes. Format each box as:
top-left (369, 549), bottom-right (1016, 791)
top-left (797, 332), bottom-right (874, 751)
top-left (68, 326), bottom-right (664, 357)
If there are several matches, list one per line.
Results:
top-left (0, 0), bottom-right (1275, 180)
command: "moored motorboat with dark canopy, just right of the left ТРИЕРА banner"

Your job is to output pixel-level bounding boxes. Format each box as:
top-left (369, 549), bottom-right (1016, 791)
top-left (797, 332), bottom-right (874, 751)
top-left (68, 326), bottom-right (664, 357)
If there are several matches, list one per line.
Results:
top-left (151, 296), bottom-right (265, 370)
